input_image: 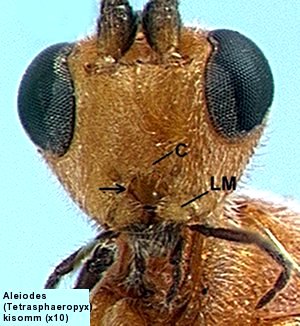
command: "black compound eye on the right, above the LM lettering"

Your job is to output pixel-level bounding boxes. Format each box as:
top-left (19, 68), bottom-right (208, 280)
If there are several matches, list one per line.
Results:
top-left (205, 30), bottom-right (274, 138)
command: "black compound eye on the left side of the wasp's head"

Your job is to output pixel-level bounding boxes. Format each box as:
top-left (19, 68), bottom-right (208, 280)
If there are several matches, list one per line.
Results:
top-left (18, 43), bottom-right (75, 155)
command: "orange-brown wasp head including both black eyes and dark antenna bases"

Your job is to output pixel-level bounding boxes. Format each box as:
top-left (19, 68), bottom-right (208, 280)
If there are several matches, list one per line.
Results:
top-left (19, 2), bottom-right (273, 230)
